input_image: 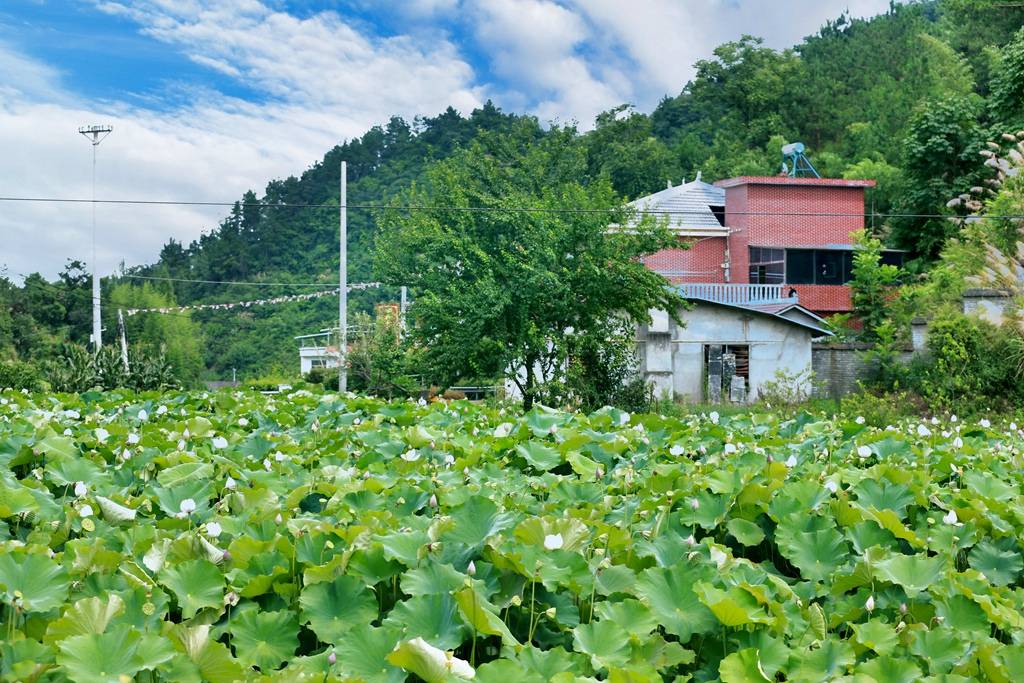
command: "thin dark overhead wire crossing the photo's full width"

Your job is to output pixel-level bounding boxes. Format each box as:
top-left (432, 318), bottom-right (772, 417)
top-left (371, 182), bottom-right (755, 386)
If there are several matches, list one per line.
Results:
top-left (0, 197), bottom-right (1024, 220)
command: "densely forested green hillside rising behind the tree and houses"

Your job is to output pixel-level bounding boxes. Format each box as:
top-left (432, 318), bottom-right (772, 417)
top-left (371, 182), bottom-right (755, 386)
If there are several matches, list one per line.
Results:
top-left (8, 0), bottom-right (1024, 378)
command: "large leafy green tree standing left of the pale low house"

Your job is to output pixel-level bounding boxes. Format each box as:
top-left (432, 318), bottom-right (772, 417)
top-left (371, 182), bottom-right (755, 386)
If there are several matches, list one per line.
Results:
top-left (377, 128), bottom-right (682, 408)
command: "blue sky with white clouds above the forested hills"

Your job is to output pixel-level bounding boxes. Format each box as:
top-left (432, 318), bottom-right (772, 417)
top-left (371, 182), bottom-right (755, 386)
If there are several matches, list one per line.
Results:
top-left (0, 0), bottom-right (889, 281)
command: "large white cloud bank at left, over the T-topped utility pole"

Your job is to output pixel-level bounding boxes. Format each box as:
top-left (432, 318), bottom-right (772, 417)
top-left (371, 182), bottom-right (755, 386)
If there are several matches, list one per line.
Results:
top-left (0, 0), bottom-right (483, 275)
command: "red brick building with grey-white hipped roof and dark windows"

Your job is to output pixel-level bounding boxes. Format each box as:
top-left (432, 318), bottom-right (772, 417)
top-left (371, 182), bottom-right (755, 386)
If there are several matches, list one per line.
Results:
top-left (634, 176), bottom-right (888, 315)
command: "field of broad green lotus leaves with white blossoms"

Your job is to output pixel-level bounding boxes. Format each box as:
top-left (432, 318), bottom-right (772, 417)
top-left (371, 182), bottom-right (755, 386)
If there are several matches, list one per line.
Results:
top-left (0, 391), bottom-right (1024, 683)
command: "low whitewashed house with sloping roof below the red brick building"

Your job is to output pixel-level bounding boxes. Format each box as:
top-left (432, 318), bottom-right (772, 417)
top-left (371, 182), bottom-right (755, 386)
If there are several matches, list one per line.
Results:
top-left (638, 284), bottom-right (831, 402)
